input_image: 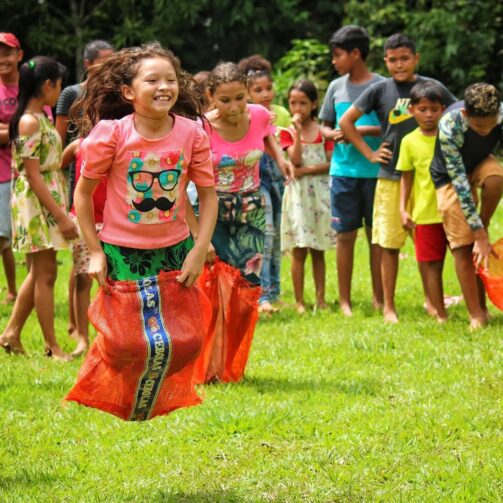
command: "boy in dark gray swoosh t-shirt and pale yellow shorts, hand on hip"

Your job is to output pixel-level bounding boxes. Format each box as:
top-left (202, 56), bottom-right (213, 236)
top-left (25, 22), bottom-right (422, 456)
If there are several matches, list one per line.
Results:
top-left (340, 33), bottom-right (456, 323)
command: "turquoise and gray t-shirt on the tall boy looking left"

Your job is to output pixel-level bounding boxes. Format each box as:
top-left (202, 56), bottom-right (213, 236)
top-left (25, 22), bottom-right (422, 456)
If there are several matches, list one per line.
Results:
top-left (319, 74), bottom-right (384, 178)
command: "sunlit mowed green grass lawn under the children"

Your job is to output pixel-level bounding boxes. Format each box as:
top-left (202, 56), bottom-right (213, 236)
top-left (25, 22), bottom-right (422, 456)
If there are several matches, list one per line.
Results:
top-left (0, 206), bottom-right (503, 502)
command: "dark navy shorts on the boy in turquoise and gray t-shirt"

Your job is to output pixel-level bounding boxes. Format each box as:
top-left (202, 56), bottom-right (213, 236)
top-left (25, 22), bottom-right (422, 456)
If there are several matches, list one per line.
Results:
top-left (330, 176), bottom-right (377, 232)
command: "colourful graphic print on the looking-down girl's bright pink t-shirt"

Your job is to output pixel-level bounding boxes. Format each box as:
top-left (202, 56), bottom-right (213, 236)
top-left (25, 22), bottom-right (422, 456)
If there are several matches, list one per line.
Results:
top-left (214, 150), bottom-right (263, 192)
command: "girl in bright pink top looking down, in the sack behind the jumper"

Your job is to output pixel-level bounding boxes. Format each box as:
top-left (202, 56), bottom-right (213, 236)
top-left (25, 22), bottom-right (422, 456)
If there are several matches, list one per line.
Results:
top-left (194, 63), bottom-right (292, 381)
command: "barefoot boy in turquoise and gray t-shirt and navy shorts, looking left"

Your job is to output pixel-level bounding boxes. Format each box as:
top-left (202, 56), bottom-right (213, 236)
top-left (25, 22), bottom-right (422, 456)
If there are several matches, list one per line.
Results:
top-left (319, 25), bottom-right (383, 316)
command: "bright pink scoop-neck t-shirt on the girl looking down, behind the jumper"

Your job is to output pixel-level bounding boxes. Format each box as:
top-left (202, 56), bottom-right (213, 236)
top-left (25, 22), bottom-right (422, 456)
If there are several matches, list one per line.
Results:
top-left (205, 105), bottom-right (271, 192)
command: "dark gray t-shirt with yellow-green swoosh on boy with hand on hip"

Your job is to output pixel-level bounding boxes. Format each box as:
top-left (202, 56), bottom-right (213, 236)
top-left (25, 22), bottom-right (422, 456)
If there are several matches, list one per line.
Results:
top-left (353, 76), bottom-right (456, 180)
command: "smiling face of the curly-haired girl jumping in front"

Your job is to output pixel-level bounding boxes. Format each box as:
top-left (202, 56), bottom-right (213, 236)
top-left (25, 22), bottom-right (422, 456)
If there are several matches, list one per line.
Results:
top-left (122, 57), bottom-right (178, 118)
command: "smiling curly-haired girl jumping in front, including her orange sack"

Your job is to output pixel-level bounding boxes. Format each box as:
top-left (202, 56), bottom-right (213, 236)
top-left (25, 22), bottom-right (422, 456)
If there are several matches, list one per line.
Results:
top-left (67, 43), bottom-right (217, 420)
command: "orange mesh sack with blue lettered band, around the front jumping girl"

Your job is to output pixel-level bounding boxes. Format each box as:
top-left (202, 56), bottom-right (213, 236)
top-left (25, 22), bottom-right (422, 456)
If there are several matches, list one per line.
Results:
top-left (66, 271), bottom-right (211, 421)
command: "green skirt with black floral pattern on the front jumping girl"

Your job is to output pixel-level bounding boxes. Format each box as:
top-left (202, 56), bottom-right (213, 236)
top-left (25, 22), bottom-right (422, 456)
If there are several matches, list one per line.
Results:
top-left (101, 237), bottom-right (194, 281)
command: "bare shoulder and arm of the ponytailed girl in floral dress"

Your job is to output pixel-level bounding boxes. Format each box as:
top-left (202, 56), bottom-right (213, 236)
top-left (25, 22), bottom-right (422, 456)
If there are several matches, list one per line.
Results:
top-left (19, 114), bottom-right (79, 239)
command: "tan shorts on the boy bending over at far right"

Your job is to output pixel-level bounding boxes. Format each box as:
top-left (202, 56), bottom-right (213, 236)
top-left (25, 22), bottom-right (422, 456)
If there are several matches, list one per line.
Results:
top-left (437, 155), bottom-right (503, 250)
